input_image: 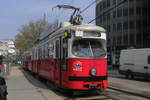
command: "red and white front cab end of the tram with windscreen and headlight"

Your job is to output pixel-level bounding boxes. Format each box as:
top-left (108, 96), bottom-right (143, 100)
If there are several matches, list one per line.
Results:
top-left (59, 25), bottom-right (107, 90)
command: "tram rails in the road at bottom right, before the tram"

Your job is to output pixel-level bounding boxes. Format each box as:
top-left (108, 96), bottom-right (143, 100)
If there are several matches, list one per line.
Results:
top-left (65, 86), bottom-right (150, 100)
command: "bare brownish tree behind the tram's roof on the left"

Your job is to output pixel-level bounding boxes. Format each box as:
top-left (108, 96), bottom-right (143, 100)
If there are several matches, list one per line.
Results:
top-left (15, 18), bottom-right (52, 52)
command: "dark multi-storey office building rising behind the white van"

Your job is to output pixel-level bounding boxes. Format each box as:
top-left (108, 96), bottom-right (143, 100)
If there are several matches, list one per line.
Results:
top-left (96, 0), bottom-right (150, 52)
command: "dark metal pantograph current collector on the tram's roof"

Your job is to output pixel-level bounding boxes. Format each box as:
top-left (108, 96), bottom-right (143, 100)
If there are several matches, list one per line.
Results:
top-left (53, 5), bottom-right (83, 25)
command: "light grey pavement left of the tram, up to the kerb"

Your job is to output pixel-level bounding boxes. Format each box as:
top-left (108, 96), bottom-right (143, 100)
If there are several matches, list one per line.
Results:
top-left (6, 67), bottom-right (46, 100)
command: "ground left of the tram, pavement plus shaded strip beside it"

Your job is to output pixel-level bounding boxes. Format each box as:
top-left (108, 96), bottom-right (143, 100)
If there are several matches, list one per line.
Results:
top-left (6, 67), bottom-right (66, 100)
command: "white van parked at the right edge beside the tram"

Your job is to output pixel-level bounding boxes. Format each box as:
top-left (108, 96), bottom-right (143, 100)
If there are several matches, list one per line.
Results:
top-left (119, 48), bottom-right (150, 79)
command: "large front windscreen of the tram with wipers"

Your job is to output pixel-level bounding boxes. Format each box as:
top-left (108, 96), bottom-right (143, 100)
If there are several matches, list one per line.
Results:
top-left (72, 39), bottom-right (106, 57)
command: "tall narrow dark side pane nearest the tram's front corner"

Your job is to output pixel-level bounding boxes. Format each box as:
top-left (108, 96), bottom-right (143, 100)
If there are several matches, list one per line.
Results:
top-left (63, 38), bottom-right (68, 70)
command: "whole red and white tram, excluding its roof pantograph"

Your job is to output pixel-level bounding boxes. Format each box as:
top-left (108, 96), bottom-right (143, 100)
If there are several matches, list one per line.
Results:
top-left (24, 22), bottom-right (107, 90)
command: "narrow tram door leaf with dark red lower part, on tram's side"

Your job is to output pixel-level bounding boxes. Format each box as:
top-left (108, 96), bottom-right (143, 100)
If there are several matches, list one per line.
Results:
top-left (55, 37), bottom-right (62, 87)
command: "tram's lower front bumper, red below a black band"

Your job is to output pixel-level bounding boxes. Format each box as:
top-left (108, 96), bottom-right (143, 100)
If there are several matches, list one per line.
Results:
top-left (68, 76), bottom-right (107, 90)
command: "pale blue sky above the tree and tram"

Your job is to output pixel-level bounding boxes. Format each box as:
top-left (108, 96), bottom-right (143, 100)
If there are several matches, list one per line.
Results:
top-left (0, 0), bottom-right (95, 39)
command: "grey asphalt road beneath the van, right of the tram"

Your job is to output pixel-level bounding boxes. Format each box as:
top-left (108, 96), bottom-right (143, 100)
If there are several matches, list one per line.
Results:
top-left (108, 69), bottom-right (150, 99)
